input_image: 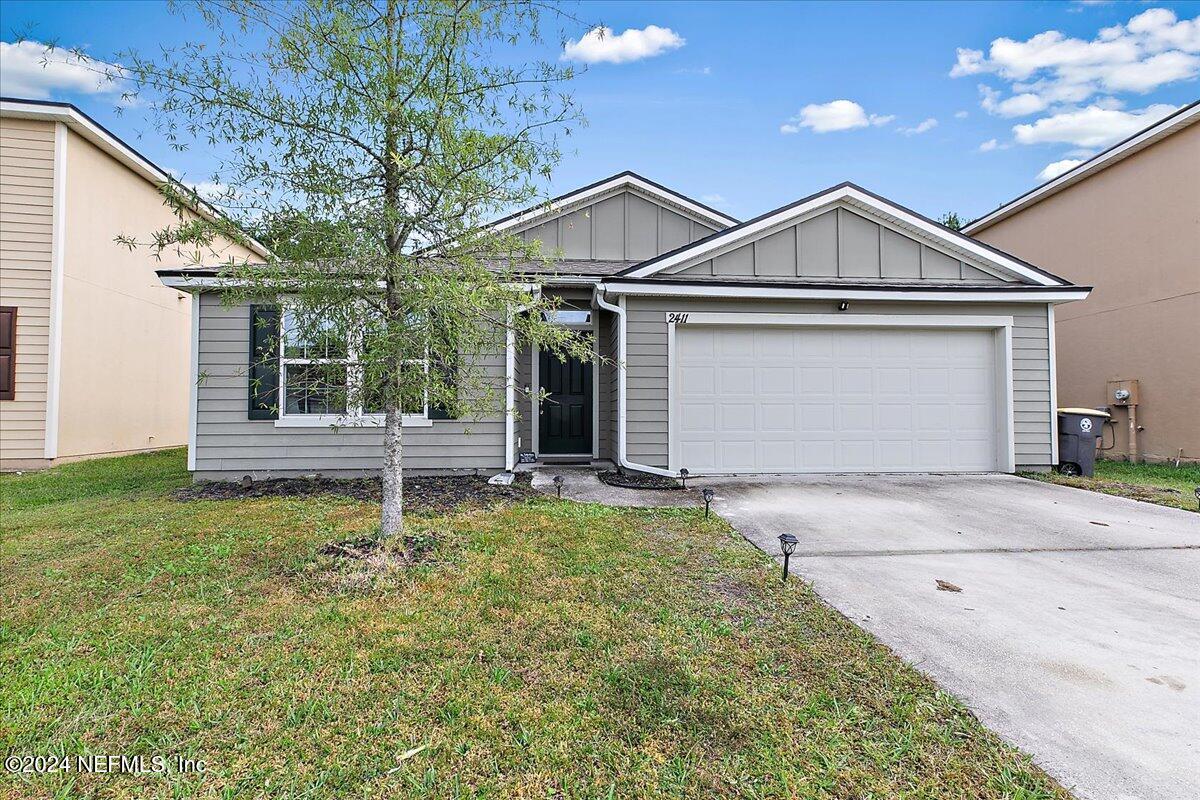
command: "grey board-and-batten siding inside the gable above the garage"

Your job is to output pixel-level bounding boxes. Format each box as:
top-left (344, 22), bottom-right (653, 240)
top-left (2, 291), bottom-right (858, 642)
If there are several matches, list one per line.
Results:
top-left (664, 207), bottom-right (1013, 283)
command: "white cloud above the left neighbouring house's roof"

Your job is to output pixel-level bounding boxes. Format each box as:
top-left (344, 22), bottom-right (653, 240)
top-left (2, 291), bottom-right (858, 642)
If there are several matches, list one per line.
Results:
top-left (0, 41), bottom-right (128, 100)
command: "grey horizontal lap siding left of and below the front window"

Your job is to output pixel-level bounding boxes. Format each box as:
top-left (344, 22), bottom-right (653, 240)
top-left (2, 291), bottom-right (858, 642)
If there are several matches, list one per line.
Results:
top-left (194, 293), bottom-right (505, 480)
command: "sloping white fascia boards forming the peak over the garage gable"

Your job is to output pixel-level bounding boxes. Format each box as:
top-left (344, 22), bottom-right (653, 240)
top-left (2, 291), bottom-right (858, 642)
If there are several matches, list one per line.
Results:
top-left (626, 186), bottom-right (1062, 287)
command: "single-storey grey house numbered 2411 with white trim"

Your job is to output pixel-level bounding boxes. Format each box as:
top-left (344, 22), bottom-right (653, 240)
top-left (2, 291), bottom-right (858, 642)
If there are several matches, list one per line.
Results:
top-left (160, 173), bottom-right (1088, 479)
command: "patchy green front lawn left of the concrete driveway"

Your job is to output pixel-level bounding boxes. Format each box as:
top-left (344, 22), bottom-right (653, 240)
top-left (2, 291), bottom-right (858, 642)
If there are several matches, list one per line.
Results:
top-left (0, 452), bottom-right (1067, 800)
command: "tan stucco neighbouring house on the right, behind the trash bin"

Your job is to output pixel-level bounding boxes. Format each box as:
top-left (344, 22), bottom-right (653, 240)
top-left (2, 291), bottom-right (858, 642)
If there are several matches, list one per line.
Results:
top-left (964, 102), bottom-right (1200, 461)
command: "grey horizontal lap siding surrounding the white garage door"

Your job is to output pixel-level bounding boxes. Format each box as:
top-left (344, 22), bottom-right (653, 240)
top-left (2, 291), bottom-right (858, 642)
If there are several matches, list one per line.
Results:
top-left (625, 296), bottom-right (1052, 469)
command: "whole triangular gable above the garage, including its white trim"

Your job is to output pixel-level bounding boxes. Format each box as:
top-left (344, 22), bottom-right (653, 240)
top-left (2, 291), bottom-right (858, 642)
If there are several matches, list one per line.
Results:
top-left (622, 184), bottom-right (1069, 285)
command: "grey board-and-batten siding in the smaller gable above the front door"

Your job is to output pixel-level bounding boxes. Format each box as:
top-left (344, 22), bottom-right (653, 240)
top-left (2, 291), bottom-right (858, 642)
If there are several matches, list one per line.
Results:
top-left (520, 188), bottom-right (716, 261)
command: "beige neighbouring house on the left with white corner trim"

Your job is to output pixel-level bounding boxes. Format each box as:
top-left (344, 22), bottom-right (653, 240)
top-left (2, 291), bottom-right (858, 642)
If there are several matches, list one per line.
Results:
top-left (0, 98), bottom-right (263, 470)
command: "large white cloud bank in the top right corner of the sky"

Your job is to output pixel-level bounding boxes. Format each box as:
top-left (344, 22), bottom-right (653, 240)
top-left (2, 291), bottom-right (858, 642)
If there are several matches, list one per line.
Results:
top-left (950, 8), bottom-right (1200, 116)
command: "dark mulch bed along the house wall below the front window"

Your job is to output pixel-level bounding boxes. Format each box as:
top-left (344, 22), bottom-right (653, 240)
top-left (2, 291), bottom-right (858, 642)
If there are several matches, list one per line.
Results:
top-left (173, 475), bottom-right (533, 511)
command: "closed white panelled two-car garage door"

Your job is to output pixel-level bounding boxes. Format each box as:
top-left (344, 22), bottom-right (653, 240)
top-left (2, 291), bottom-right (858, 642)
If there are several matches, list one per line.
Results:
top-left (671, 325), bottom-right (1002, 474)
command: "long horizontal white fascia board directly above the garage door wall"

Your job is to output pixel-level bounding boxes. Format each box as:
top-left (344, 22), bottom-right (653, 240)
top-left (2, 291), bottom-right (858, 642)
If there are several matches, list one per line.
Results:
top-left (600, 282), bottom-right (1090, 303)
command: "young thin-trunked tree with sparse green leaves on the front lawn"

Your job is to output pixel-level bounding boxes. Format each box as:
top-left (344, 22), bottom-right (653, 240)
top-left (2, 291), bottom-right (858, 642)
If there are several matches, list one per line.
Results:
top-left (114, 0), bottom-right (589, 536)
